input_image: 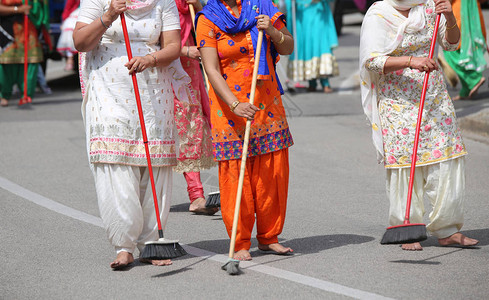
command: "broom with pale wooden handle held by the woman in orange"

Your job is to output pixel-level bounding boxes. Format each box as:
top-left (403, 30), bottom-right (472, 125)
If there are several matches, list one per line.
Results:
top-left (221, 30), bottom-right (263, 275)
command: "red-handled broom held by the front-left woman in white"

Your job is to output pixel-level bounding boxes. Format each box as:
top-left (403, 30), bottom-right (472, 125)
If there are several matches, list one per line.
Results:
top-left (121, 13), bottom-right (187, 260)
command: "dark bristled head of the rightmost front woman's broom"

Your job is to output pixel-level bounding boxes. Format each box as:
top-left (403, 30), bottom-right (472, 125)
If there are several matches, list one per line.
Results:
top-left (380, 223), bottom-right (428, 245)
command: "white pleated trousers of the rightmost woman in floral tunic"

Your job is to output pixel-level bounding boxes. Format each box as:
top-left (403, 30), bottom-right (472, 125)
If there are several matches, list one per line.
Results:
top-left (386, 157), bottom-right (465, 239)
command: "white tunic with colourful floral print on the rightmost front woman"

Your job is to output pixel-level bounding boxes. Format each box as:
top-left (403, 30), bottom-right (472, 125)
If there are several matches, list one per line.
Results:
top-left (366, 2), bottom-right (467, 168)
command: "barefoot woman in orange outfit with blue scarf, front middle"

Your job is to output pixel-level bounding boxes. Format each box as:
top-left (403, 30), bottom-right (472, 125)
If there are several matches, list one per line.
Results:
top-left (197, 0), bottom-right (294, 260)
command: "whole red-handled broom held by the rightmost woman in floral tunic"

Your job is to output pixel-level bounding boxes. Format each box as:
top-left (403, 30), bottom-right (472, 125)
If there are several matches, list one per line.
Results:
top-left (380, 14), bottom-right (440, 245)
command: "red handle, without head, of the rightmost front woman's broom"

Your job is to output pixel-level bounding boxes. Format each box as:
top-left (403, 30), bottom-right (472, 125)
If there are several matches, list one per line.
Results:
top-left (404, 14), bottom-right (441, 224)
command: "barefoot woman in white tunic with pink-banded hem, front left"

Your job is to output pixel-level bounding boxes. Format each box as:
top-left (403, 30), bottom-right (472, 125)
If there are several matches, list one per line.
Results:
top-left (73, 0), bottom-right (186, 269)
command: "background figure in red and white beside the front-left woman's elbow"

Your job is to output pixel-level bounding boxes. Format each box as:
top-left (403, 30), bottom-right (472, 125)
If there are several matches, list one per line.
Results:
top-left (56, 0), bottom-right (80, 71)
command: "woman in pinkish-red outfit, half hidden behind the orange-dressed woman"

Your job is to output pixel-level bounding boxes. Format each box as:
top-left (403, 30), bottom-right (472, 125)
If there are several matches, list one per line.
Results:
top-left (175, 0), bottom-right (215, 215)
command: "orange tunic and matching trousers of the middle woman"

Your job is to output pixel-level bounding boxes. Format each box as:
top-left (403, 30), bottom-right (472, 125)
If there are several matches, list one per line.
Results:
top-left (196, 0), bottom-right (293, 251)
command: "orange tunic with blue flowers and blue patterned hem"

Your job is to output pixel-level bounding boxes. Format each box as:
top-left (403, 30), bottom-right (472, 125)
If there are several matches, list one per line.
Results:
top-left (197, 0), bottom-right (293, 161)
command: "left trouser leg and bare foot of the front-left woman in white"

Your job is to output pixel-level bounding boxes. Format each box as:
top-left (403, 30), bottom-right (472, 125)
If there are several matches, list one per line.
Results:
top-left (93, 164), bottom-right (143, 268)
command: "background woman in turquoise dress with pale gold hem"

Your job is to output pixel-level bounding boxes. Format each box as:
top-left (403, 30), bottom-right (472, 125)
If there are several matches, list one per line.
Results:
top-left (286, 0), bottom-right (339, 93)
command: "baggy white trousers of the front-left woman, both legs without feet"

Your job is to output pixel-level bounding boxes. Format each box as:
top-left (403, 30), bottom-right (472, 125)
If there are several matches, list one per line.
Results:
top-left (93, 164), bottom-right (173, 253)
